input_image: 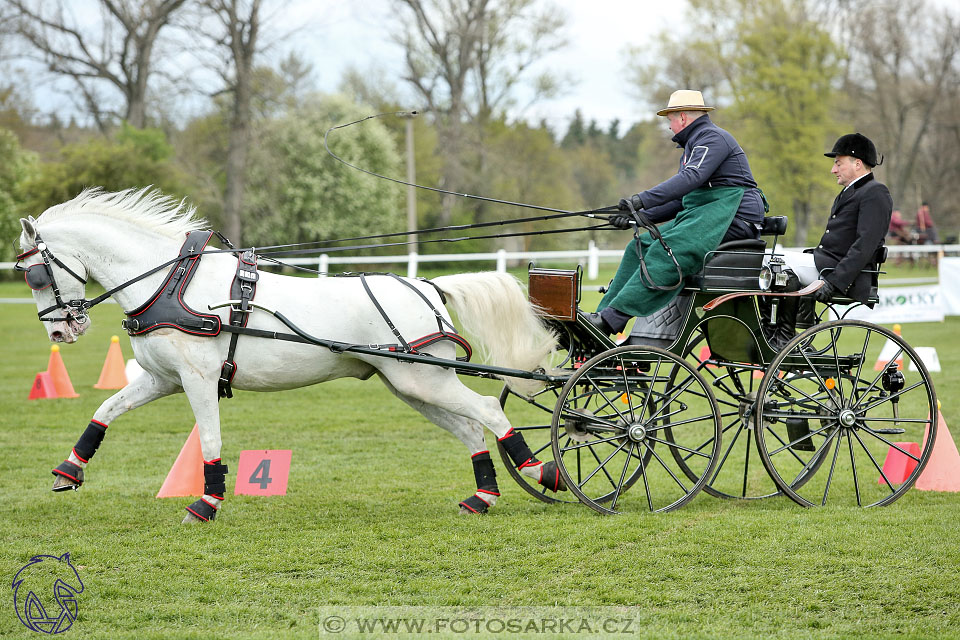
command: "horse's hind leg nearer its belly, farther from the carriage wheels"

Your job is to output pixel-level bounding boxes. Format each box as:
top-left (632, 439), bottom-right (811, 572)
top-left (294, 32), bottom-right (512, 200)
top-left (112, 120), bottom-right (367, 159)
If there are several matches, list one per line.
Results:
top-left (380, 375), bottom-right (500, 514)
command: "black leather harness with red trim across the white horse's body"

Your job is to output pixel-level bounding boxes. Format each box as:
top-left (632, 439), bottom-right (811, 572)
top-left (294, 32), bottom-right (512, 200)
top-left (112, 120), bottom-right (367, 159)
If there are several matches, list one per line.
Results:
top-left (121, 231), bottom-right (473, 398)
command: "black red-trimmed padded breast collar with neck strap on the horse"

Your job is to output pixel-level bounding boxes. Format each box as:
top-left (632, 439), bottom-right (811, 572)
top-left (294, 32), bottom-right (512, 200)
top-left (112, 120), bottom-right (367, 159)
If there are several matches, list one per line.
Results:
top-left (122, 231), bottom-right (220, 336)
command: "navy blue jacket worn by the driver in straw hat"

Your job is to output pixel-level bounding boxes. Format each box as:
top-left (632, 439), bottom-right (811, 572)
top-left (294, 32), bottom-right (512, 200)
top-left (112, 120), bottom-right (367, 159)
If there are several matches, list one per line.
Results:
top-left (638, 115), bottom-right (764, 225)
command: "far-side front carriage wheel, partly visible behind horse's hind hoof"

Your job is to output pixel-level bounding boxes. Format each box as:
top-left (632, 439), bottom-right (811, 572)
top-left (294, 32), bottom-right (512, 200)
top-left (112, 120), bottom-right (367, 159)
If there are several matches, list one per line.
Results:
top-left (497, 385), bottom-right (578, 503)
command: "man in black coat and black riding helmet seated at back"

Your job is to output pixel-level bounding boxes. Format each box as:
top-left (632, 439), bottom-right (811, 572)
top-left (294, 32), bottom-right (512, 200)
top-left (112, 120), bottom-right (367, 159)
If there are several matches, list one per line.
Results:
top-left (768, 133), bottom-right (893, 304)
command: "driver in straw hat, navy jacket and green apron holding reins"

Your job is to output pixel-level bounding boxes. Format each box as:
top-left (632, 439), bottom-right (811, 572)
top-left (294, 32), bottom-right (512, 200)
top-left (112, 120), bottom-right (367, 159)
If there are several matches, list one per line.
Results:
top-left (587, 90), bottom-right (767, 333)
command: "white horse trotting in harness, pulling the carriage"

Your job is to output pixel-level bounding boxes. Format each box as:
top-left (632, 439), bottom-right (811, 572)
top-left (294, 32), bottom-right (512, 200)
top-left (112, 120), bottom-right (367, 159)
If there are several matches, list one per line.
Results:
top-left (18, 189), bottom-right (564, 522)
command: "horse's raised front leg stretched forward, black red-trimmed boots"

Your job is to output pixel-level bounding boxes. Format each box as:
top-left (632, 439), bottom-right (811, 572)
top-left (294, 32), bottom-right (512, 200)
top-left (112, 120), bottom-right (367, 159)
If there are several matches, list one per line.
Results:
top-left (53, 371), bottom-right (180, 491)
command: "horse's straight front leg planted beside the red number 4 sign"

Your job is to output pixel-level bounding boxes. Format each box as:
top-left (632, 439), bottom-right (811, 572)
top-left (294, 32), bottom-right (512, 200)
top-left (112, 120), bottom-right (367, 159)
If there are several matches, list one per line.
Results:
top-left (181, 376), bottom-right (227, 524)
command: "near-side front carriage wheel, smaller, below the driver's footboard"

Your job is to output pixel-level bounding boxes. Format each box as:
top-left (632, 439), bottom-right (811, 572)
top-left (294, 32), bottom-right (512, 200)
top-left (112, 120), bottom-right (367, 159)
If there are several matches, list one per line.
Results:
top-left (551, 346), bottom-right (720, 513)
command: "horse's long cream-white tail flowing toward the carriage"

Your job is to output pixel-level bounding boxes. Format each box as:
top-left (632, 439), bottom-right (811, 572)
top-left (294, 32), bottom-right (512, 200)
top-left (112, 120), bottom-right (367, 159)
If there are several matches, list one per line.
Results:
top-left (433, 271), bottom-right (557, 394)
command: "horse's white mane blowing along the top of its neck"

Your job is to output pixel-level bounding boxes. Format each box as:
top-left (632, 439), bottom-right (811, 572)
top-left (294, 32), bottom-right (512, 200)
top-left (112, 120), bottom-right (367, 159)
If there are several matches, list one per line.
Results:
top-left (37, 187), bottom-right (209, 238)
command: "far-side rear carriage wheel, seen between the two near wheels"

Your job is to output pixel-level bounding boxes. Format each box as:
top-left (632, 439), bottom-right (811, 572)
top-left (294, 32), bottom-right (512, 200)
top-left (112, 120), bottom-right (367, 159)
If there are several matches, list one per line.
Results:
top-left (672, 329), bottom-right (780, 500)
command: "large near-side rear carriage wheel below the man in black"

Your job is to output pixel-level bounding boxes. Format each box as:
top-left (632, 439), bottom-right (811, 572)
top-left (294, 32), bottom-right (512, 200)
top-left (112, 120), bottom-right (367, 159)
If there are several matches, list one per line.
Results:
top-left (756, 320), bottom-right (937, 507)
